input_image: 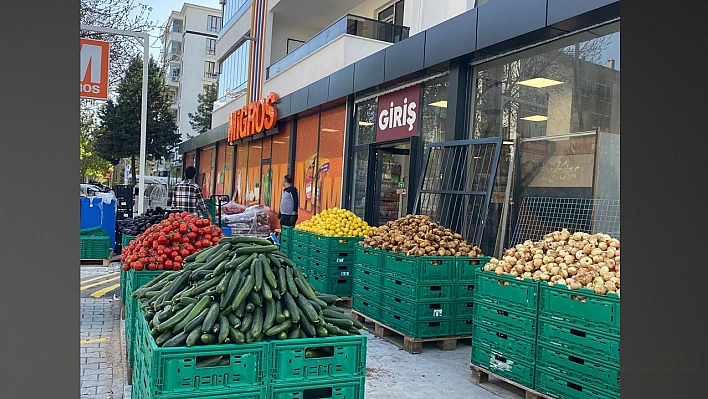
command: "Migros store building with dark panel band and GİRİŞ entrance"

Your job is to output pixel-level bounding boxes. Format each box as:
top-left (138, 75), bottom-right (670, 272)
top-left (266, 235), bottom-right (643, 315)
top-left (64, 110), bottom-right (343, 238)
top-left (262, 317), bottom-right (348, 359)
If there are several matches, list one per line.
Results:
top-left (180, 0), bottom-right (620, 254)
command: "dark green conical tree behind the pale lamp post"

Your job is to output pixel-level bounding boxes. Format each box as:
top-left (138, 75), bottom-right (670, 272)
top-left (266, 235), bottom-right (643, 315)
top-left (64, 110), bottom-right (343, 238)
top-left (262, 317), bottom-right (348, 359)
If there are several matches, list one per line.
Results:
top-left (95, 57), bottom-right (180, 185)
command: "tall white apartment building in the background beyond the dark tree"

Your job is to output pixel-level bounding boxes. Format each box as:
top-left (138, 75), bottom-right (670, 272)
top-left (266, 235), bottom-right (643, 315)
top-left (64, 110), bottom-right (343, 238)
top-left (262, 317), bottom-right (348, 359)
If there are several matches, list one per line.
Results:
top-left (161, 2), bottom-right (222, 141)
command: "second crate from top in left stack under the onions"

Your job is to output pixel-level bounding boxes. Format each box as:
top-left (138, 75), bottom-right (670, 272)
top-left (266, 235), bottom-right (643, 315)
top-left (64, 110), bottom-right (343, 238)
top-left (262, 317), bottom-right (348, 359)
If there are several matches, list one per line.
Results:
top-left (474, 302), bottom-right (538, 340)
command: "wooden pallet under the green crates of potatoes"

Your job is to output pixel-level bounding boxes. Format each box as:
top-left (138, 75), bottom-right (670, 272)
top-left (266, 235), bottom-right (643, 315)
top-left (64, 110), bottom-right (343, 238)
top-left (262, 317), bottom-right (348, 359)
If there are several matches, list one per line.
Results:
top-left (352, 310), bottom-right (472, 354)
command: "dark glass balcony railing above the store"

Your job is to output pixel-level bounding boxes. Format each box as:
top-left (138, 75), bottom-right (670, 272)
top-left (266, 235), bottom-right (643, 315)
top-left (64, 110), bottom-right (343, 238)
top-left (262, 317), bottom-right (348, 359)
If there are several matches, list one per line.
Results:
top-left (266, 14), bottom-right (410, 79)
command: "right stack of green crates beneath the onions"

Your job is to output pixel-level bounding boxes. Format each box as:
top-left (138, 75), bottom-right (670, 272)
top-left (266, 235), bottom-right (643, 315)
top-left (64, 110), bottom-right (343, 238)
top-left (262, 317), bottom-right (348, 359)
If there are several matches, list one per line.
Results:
top-left (535, 282), bottom-right (620, 398)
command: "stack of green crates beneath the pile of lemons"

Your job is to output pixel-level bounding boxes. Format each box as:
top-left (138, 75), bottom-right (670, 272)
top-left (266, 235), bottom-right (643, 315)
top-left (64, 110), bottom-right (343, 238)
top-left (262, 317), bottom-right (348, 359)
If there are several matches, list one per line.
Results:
top-left (291, 230), bottom-right (362, 297)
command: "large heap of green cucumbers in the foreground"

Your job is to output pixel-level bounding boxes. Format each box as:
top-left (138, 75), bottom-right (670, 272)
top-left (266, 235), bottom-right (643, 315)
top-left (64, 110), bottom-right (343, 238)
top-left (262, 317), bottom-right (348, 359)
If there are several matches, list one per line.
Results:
top-left (132, 237), bottom-right (363, 347)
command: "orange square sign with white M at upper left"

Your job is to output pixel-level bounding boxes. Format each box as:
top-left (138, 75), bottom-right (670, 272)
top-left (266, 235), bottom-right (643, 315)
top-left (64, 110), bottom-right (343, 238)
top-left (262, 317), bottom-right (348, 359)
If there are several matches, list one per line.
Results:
top-left (81, 39), bottom-right (109, 100)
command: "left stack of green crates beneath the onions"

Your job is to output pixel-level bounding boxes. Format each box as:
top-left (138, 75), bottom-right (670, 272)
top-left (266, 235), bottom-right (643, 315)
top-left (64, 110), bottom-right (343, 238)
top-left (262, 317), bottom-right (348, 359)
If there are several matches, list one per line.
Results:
top-left (471, 271), bottom-right (538, 389)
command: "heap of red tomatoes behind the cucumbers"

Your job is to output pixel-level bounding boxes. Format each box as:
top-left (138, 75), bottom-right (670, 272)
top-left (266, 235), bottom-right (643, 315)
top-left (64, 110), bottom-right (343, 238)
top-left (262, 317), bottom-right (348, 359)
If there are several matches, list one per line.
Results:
top-left (120, 212), bottom-right (223, 271)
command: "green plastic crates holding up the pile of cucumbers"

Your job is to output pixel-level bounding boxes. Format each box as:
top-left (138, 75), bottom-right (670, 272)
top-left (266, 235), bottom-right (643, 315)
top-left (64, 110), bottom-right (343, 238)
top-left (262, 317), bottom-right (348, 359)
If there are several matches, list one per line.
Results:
top-left (132, 315), bottom-right (366, 399)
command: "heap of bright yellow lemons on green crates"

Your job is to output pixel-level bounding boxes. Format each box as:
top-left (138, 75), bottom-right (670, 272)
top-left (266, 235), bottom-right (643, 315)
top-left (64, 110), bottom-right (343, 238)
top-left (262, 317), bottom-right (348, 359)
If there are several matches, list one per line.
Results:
top-left (295, 208), bottom-right (375, 237)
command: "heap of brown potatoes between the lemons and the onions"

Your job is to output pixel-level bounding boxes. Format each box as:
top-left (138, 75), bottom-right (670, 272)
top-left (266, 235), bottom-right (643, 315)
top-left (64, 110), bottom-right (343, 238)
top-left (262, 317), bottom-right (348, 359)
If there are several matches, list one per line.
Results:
top-left (361, 215), bottom-right (483, 256)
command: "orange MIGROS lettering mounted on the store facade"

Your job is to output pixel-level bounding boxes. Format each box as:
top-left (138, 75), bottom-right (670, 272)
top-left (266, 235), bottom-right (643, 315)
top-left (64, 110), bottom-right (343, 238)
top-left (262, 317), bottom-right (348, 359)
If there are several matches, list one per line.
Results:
top-left (228, 93), bottom-right (278, 142)
